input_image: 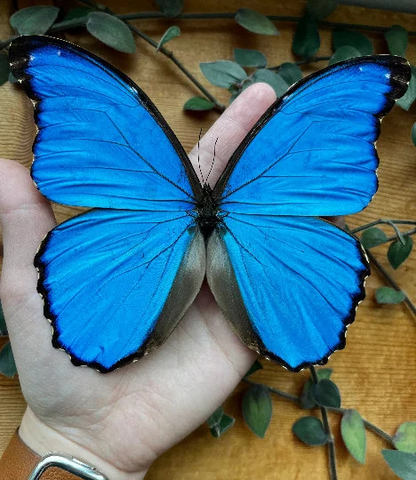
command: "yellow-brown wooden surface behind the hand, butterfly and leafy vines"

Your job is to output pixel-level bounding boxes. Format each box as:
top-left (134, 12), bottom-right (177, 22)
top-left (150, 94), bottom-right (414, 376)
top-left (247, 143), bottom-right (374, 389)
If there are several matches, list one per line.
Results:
top-left (0, 0), bottom-right (416, 480)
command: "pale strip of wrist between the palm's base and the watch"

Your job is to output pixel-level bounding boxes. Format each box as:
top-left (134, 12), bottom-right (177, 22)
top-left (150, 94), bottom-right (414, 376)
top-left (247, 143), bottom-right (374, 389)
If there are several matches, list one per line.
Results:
top-left (19, 408), bottom-right (147, 480)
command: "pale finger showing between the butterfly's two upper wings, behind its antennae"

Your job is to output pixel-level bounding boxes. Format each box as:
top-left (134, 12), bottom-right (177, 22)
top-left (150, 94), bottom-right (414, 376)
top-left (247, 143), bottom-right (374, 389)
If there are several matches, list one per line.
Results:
top-left (189, 83), bottom-right (276, 185)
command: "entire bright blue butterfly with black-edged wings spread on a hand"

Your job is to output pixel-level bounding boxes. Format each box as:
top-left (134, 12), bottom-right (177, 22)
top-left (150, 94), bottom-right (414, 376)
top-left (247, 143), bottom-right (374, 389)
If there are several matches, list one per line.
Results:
top-left (10, 36), bottom-right (410, 372)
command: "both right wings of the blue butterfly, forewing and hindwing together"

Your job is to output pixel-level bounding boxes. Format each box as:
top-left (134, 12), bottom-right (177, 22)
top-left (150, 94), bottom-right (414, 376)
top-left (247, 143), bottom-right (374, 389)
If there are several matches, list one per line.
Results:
top-left (207, 56), bottom-right (410, 371)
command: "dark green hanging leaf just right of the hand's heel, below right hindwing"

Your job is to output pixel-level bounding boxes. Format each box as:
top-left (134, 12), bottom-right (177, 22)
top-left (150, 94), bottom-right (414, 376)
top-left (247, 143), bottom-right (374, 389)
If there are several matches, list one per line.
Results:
top-left (243, 385), bottom-right (273, 438)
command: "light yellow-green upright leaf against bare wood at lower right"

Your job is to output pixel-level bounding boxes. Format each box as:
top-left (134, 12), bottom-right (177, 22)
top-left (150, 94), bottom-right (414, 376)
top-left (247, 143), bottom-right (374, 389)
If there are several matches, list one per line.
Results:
top-left (341, 409), bottom-right (367, 465)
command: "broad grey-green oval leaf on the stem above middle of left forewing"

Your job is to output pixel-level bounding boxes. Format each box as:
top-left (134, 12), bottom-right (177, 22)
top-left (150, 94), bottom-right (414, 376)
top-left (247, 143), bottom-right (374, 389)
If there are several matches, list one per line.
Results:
top-left (86, 12), bottom-right (136, 53)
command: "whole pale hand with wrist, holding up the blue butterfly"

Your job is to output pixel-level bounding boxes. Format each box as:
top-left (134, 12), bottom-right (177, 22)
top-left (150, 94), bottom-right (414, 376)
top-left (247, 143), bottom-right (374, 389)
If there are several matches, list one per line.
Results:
top-left (0, 84), bottom-right (342, 480)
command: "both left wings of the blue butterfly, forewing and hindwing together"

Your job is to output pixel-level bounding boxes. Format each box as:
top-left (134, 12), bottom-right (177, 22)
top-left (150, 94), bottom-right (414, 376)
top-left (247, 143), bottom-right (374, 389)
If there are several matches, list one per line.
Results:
top-left (10, 36), bottom-right (205, 372)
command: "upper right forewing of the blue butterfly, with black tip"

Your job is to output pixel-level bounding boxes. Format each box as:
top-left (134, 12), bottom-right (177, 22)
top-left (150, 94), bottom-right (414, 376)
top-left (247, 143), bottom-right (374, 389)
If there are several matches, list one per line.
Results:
top-left (214, 55), bottom-right (410, 216)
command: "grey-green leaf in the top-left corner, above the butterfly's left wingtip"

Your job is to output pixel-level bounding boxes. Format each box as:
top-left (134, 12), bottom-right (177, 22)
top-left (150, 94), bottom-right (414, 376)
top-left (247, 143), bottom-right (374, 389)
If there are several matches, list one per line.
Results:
top-left (10, 5), bottom-right (59, 35)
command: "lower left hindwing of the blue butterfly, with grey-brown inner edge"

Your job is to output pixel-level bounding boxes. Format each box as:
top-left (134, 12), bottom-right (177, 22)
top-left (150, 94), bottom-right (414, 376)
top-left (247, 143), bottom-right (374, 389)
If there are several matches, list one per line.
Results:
top-left (35, 209), bottom-right (205, 372)
